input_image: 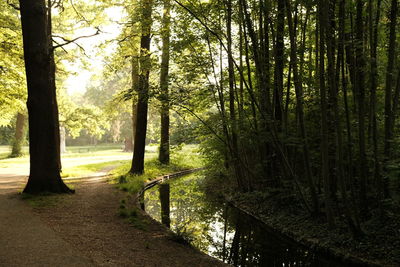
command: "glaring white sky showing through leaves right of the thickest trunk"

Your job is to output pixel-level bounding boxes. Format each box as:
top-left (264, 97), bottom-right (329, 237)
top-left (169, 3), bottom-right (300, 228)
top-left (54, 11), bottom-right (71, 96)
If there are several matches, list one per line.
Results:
top-left (65, 7), bottom-right (124, 95)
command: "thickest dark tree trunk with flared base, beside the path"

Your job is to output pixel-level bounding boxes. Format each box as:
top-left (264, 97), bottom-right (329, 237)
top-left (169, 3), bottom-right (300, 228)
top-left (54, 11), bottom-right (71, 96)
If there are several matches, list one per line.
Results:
top-left (20, 0), bottom-right (73, 194)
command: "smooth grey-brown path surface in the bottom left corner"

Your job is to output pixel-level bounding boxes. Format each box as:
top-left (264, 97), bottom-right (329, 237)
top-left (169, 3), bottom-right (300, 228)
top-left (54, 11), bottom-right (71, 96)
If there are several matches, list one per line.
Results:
top-left (0, 193), bottom-right (93, 266)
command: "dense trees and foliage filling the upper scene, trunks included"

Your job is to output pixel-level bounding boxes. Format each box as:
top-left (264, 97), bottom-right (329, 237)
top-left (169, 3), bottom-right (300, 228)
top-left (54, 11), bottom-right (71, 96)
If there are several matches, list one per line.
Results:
top-left (0, 0), bottom-right (400, 264)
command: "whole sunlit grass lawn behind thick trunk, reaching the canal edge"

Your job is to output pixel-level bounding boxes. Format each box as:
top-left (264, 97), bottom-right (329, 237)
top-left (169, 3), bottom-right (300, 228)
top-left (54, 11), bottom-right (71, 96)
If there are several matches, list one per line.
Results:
top-left (0, 145), bottom-right (203, 199)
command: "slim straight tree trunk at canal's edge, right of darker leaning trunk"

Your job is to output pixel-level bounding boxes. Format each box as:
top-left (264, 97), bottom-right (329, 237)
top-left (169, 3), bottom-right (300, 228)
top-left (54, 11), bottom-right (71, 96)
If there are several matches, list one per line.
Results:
top-left (158, 0), bottom-right (171, 164)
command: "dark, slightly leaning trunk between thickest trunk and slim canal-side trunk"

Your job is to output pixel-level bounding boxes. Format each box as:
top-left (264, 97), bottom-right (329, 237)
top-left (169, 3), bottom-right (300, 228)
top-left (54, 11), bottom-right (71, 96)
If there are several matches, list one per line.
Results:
top-left (130, 0), bottom-right (153, 174)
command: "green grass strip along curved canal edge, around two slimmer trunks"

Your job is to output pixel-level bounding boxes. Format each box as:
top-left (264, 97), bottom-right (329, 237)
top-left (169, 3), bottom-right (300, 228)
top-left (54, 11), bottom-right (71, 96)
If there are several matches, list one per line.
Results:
top-left (111, 145), bottom-right (203, 194)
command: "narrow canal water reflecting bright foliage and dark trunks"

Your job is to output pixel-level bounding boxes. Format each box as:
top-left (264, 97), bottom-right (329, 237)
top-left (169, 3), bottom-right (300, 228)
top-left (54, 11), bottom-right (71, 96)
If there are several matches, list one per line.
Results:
top-left (145, 174), bottom-right (344, 266)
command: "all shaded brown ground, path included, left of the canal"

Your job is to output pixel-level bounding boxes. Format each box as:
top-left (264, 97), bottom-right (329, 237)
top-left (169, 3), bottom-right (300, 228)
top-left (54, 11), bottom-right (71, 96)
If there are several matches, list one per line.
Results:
top-left (0, 166), bottom-right (224, 266)
